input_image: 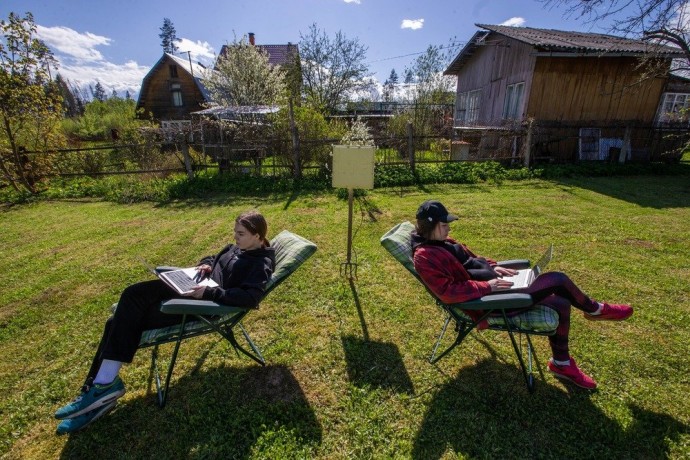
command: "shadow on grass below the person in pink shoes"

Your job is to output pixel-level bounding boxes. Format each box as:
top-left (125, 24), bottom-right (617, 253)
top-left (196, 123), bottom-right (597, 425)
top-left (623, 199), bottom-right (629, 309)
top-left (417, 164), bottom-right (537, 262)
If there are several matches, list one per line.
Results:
top-left (413, 359), bottom-right (689, 460)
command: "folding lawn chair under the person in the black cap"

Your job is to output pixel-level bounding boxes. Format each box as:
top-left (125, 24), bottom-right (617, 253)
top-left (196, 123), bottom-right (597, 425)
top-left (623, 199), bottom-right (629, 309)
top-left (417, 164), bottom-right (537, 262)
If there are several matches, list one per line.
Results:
top-left (381, 222), bottom-right (558, 392)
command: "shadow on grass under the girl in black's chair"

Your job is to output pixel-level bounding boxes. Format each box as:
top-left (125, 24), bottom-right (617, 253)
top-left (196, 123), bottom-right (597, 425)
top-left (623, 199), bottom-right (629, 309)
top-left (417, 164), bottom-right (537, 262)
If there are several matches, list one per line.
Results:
top-left (61, 366), bottom-right (322, 459)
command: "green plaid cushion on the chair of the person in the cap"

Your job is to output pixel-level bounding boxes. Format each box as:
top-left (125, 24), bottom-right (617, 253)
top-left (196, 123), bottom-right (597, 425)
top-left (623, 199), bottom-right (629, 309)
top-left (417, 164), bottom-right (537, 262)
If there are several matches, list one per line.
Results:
top-left (381, 222), bottom-right (558, 332)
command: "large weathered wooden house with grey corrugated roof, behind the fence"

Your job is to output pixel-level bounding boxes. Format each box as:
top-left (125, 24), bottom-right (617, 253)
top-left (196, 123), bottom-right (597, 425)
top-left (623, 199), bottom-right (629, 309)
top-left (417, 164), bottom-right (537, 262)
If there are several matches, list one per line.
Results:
top-left (444, 24), bottom-right (690, 161)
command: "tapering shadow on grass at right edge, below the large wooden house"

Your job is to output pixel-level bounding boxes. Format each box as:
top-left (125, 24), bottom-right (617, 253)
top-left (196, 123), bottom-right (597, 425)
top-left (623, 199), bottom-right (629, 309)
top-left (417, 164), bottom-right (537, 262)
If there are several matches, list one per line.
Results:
top-left (556, 172), bottom-right (690, 209)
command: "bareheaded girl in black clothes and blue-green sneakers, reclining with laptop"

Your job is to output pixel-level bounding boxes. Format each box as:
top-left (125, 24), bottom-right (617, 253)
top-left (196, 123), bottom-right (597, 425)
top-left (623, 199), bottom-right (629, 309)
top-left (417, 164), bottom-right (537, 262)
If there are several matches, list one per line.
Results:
top-left (55, 212), bottom-right (275, 434)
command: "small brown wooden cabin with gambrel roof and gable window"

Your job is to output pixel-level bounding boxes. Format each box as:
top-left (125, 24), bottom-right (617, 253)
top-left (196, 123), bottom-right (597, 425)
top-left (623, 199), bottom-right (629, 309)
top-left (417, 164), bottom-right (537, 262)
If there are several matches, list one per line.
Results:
top-left (137, 53), bottom-right (211, 125)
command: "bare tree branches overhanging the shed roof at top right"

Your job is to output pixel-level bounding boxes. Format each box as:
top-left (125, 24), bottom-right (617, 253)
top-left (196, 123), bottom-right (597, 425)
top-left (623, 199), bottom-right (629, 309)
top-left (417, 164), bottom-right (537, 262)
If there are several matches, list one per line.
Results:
top-left (538, 0), bottom-right (690, 71)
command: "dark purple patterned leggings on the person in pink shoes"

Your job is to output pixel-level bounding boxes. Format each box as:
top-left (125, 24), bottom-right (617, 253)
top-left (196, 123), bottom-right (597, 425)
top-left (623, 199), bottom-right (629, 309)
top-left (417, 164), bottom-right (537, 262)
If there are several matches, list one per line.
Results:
top-left (522, 272), bottom-right (599, 361)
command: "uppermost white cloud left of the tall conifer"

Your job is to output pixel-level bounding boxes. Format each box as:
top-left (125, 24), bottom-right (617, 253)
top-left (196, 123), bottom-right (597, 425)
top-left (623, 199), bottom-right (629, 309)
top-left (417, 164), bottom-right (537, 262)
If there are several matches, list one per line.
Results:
top-left (36, 25), bottom-right (112, 61)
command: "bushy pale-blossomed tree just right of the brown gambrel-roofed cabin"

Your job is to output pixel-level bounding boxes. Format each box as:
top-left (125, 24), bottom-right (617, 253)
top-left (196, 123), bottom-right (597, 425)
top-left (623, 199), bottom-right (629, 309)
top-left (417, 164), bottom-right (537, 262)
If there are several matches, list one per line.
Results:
top-left (205, 38), bottom-right (287, 106)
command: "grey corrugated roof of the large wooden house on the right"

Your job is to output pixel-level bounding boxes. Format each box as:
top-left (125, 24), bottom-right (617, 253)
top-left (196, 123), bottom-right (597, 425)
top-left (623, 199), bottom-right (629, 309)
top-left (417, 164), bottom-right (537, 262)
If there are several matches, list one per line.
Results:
top-left (444, 24), bottom-right (683, 75)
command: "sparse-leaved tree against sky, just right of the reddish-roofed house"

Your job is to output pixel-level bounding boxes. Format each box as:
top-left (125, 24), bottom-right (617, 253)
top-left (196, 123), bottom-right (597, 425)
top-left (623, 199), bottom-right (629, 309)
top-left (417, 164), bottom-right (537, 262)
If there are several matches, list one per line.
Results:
top-left (299, 24), bottom-right (371, 114)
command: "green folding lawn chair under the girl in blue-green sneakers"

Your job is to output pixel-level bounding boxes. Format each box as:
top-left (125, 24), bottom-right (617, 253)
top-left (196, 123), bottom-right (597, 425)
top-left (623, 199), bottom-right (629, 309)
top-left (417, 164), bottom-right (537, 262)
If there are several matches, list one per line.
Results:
top-left (113, 230), bottom-right (316, 407)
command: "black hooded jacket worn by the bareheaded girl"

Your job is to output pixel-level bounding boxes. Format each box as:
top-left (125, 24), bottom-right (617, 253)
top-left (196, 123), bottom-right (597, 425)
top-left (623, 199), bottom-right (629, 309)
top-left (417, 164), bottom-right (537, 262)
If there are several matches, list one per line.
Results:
top-left (199, 244), bottom-right (275, 308)
